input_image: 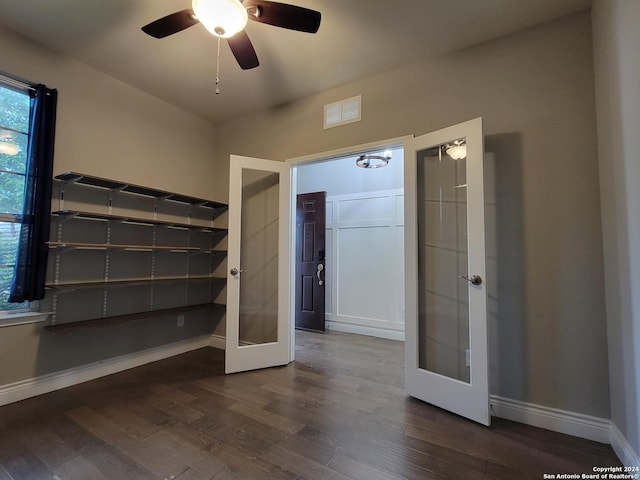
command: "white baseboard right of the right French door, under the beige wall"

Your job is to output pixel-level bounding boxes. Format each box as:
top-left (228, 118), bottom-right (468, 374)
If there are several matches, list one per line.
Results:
top-left (490, 395), bottom-right (611, 443)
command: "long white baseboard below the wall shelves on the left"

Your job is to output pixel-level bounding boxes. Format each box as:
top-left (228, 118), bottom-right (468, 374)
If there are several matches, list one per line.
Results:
top-left (0, 335), bottom-right (210, 406)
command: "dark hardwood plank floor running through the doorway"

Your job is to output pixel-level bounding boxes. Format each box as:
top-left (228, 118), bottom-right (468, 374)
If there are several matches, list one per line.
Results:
top-left (0, 331), bottom-right (620, 480)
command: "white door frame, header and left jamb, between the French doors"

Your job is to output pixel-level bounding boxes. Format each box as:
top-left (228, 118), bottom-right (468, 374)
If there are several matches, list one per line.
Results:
top-left (285, 135), bottom-right (414, 362)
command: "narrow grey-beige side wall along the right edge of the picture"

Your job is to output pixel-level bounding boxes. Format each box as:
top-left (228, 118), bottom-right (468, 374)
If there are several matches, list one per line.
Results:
top-left (593, 0), bottom-right (640, 465)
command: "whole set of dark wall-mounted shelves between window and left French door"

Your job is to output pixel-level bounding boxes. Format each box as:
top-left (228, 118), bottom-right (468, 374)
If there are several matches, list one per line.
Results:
top-left (50, 172), bottom-right (228, 334)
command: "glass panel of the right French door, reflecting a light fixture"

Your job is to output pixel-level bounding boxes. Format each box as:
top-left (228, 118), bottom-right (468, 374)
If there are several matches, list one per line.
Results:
top-left (417, 139), bottom-right (470, 383)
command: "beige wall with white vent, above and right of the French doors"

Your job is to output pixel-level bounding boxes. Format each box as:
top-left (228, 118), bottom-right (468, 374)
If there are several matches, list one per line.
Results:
top-left (216, 13), bottom-right (609, 418)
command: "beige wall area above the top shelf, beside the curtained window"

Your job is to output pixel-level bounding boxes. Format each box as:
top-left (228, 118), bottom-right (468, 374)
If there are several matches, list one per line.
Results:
top-left (0, 30), bottom-right (220, 200)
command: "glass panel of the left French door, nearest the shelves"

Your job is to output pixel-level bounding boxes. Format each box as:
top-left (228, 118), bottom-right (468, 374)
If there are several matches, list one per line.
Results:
top-left (238, 169), bottom-right (280, 346)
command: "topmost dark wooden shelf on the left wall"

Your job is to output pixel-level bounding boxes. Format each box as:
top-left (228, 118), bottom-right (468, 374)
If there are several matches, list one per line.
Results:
top-left (54, 172), bottom-right (228, 213)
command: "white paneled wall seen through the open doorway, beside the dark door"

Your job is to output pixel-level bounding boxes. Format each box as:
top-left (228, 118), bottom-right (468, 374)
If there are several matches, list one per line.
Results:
top-left (292, 139), bottom-right (404, 341)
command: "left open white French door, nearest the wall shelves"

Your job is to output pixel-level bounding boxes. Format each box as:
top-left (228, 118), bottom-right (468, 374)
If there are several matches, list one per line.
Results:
top-left (225, 155), bottom-right (292, 373)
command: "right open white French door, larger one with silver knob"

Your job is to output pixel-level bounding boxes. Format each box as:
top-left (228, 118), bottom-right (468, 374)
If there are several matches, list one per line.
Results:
top-left (404, 118), bottom-right (491, 425)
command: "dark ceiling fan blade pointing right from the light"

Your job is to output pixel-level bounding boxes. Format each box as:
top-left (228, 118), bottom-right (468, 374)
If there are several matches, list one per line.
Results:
top-left (243, 0), bottom-right (322, 33)
